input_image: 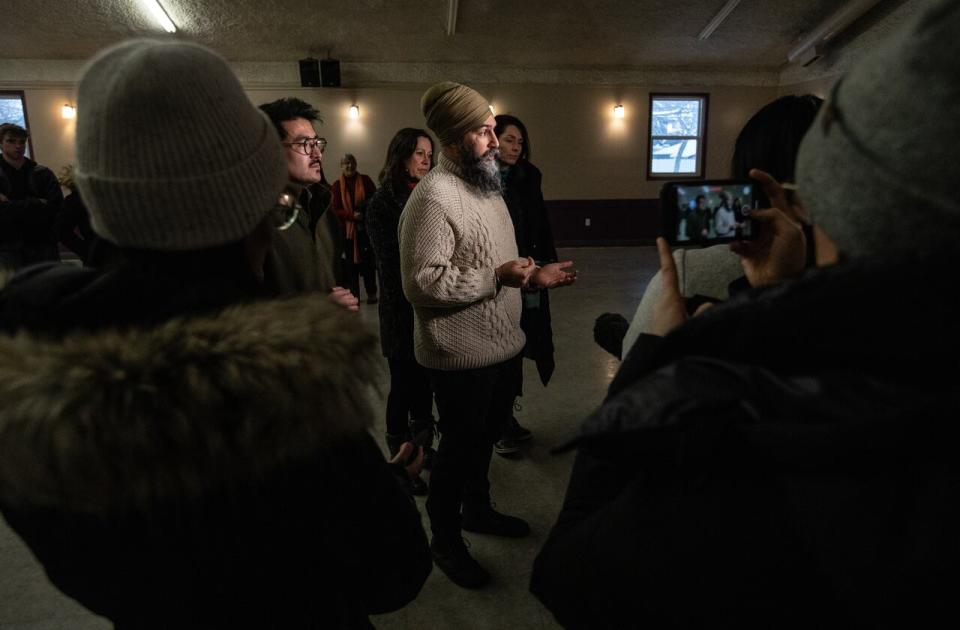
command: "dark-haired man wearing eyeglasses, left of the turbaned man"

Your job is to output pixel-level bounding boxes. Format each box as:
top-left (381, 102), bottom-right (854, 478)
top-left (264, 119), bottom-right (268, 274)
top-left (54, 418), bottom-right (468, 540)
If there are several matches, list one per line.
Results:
top-left (260, 98), bottom-right (358, 310)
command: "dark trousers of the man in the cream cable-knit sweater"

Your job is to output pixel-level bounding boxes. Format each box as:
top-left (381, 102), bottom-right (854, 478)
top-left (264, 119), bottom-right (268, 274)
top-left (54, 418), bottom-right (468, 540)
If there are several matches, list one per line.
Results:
top-left (427, 355), bottom-right (522, 537)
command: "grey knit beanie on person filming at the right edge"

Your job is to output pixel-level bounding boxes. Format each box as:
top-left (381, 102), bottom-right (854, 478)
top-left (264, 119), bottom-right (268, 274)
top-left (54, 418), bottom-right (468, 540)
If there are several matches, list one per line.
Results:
top-left (797, 0), bottom-right (960, 258)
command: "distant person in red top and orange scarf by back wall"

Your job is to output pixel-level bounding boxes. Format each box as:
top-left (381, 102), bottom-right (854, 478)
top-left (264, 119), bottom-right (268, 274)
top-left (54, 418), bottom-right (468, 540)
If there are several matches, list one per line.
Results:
top-left (331, 153), bottom-right (377, 304)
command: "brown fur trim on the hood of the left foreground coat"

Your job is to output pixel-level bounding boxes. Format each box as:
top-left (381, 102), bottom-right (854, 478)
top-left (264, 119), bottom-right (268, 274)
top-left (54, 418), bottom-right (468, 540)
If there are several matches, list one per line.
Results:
top-left (0, 295), bottom-right (380, 514)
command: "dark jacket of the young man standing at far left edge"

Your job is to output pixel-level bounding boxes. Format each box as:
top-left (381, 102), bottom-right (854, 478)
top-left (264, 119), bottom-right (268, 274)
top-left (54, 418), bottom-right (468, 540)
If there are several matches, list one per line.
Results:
top-left (0, 157), bottom-right (63, 269)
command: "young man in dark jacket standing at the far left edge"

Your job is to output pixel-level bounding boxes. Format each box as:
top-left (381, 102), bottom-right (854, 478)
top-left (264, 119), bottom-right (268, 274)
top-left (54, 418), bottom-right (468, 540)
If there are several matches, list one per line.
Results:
top-left (0, 123), bottom-right (63, 269)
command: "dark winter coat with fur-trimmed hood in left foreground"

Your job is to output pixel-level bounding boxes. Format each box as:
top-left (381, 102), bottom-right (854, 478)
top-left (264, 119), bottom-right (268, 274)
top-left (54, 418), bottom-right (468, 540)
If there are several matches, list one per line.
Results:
top-left (0, 256), bottom-right (431, 629)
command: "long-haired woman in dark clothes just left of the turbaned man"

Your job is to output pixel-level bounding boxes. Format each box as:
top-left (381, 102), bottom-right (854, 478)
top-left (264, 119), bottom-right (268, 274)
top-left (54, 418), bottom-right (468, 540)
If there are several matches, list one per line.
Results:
top-left (366, 127), bottom-right (433, 494)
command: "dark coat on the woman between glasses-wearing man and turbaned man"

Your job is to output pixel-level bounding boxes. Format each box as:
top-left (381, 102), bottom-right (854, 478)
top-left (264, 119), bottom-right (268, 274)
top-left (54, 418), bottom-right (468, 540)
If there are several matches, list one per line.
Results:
top-left (366, 181), bottom-right (414, 360)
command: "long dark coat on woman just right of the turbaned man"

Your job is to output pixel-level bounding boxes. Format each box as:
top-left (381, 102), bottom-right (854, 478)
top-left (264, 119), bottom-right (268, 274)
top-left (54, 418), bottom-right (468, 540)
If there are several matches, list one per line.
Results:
top-left (503, 159), bottom-right (558, 385)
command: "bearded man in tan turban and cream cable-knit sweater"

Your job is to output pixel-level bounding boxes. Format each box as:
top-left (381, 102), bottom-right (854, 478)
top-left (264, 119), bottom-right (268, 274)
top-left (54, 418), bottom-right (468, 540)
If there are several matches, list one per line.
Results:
top-left (400, 82), bottom-right (576, 588)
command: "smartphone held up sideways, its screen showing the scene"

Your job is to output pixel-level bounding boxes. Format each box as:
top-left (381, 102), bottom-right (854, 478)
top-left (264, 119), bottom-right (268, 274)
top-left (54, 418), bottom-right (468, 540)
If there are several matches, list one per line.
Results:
top-left (660, 179), bottom-right (759, 246)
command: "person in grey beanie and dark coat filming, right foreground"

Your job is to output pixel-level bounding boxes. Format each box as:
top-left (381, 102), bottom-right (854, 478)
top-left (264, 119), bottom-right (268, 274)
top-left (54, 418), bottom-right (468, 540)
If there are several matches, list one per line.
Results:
top-left (531, 0), bottom-right (960, 629)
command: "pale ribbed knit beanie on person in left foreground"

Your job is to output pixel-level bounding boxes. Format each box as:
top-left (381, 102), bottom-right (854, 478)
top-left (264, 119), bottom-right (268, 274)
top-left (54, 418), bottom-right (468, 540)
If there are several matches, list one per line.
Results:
top-left (76, 39), bottom-right (288, 251)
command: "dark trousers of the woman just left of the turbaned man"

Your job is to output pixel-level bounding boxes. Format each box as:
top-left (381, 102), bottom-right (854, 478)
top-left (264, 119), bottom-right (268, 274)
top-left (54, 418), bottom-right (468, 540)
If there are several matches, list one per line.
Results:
top-left (387, 359), bottom-right (433, 436)
